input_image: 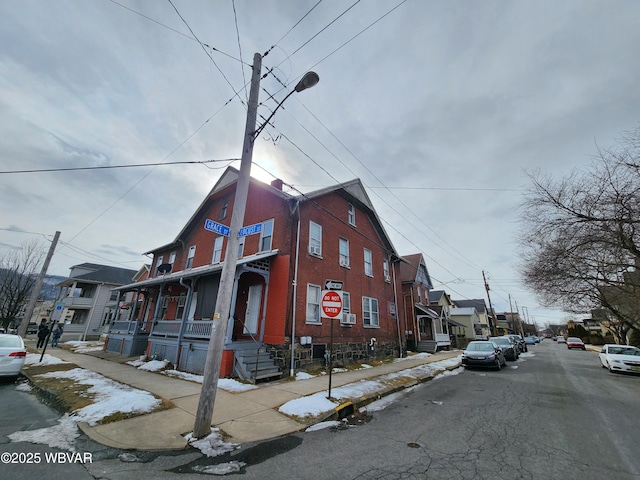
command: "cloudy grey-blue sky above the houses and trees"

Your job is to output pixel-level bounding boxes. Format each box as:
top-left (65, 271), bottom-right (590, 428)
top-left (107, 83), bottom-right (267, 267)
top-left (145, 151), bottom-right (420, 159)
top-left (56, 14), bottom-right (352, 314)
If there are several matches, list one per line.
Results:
top-left (0, 0), bottom-right (640, 326)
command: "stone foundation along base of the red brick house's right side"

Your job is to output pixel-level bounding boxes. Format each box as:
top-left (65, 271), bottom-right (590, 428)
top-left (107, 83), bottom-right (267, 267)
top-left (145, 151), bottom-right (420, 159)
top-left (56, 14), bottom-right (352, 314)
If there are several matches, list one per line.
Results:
top-left (265, 342), bottom-right (399, 376)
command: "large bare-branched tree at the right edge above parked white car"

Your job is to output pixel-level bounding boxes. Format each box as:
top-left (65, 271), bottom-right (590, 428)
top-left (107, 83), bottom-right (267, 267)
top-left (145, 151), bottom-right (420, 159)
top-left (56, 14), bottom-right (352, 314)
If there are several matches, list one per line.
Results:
top-left (520, 125), bottom-right (640, 340)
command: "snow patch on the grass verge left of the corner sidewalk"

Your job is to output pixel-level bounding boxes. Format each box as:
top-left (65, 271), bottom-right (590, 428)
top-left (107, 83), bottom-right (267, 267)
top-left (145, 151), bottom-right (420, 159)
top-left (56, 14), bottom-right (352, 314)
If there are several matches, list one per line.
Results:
top-left (8, 366), bottom-right (160, 451)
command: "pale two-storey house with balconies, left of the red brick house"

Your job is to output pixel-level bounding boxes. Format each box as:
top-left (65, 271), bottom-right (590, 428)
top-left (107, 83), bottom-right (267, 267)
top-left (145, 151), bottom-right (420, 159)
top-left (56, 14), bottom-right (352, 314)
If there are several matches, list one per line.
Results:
top-left (56, 263), bottom-right (136, 340)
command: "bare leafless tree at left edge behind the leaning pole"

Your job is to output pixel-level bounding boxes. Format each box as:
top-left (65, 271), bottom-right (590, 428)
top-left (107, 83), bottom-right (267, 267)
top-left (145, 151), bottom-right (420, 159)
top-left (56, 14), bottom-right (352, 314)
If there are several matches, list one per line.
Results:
top-left (0, 240), bottom-right (45, 328)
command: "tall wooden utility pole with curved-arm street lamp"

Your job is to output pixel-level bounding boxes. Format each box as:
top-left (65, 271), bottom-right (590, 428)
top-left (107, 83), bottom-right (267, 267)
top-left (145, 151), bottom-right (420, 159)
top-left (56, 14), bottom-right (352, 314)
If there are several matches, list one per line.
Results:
top-left (193, 53), bottom-right (320, 438)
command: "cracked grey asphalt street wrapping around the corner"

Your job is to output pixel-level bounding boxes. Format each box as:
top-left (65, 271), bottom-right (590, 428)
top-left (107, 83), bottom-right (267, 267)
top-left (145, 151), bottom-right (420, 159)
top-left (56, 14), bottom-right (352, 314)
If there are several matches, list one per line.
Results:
top-left (0, 340), bottom-right (640, 480)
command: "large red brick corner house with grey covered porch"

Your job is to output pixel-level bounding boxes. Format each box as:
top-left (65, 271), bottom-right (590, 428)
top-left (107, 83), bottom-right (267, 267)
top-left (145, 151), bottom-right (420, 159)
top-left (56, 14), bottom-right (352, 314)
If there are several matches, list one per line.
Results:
top-left (106, 168), bottom-right (404, 381)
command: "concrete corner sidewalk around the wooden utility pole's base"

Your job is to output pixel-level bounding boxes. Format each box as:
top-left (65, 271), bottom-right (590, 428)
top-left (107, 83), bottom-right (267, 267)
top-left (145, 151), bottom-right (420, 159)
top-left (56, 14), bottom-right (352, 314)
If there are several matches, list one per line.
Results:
top-left (20, 342), bottom-right (460, 450)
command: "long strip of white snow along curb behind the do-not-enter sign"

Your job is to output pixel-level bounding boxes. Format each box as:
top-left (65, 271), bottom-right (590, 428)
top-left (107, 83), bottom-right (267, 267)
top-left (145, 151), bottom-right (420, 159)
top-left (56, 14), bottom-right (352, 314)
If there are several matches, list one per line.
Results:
top-left (278, 355), bottom-right (461, 417)
